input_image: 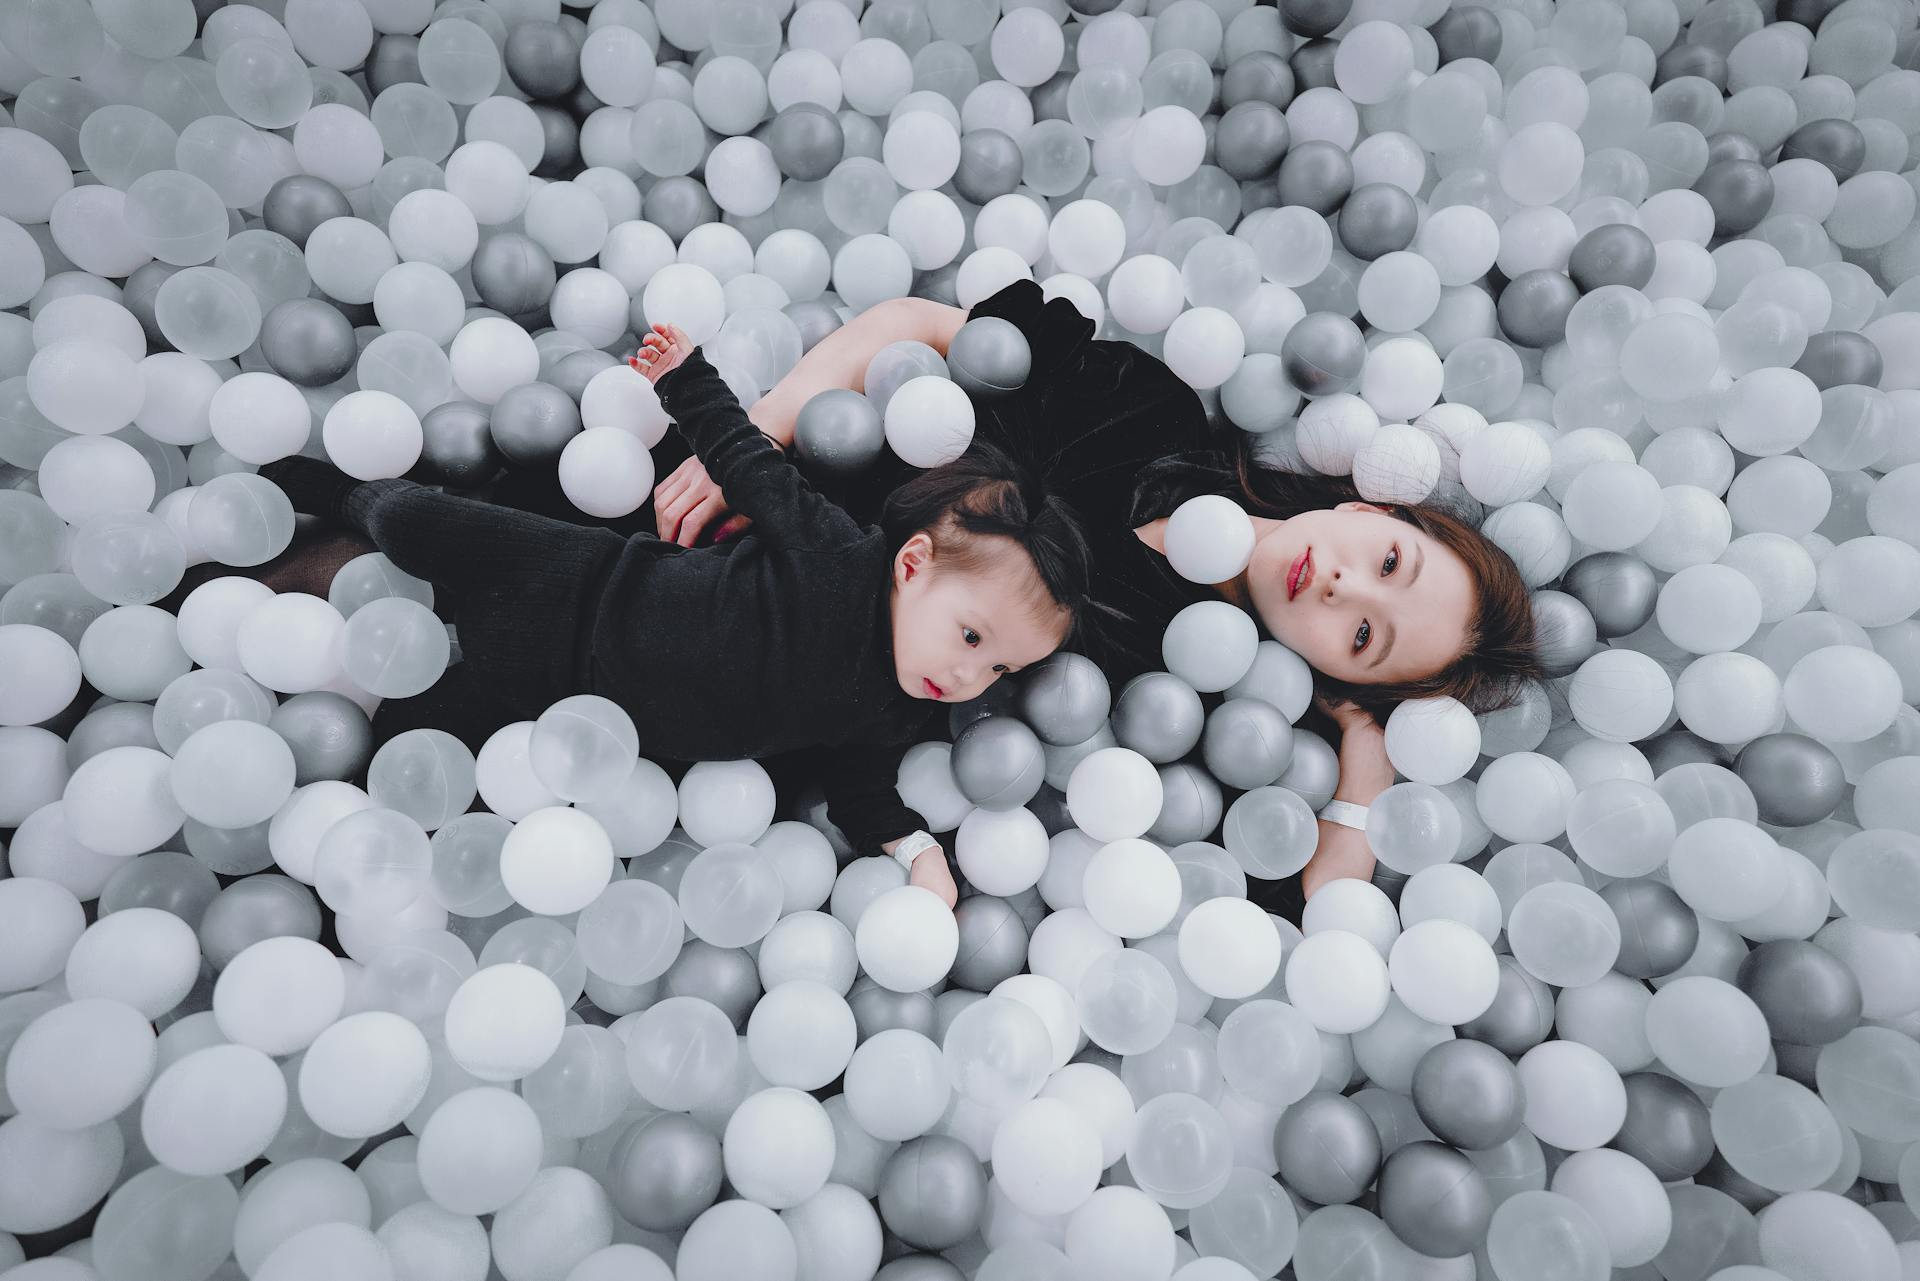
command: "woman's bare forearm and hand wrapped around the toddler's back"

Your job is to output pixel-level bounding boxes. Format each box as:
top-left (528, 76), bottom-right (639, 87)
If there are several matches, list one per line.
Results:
top-left (653, 298), bottom-right (968, 547)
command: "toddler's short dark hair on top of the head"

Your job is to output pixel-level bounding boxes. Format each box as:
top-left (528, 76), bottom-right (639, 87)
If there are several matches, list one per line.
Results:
top-left (879, 440), bottom-right (1094, 636)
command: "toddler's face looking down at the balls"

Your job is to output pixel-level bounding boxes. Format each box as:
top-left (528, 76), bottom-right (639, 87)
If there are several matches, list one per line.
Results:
top-left (893, 567), bottom-right (1068, 703)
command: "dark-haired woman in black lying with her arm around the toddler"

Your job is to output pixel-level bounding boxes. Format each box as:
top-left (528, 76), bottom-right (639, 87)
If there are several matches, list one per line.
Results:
top-left (637, 280), bottom-right (1540, 895)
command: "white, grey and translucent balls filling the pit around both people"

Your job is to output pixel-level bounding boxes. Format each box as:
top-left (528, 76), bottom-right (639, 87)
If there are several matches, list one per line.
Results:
top-left (0, 0), bottom-right (1920, 1281)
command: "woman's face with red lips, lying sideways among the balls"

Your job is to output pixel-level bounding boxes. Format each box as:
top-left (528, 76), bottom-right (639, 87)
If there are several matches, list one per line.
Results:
top-left (1246, 503), bottom-right (1475, 686)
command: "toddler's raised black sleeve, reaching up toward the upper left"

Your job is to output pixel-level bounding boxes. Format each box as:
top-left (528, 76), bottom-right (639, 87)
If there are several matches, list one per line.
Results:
top-left (655, 350), bottom-right (866, 547)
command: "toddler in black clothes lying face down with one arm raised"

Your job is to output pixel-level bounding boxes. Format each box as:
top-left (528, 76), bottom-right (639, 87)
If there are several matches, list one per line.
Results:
top-left (261, 326), bottom-right (1091, 905)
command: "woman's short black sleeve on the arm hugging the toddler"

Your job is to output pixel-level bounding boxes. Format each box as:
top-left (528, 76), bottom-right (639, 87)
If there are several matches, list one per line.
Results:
top-left (970, 280), bottom-right (1212, 526)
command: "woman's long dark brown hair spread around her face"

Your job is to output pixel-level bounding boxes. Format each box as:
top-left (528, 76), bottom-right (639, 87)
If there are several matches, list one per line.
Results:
top-left (1235, 436), bottom-right (1546, 720)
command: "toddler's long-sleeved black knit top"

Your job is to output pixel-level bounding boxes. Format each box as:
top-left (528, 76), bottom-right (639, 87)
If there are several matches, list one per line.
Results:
top-left (586, 351), bottom-right (937, 849)
